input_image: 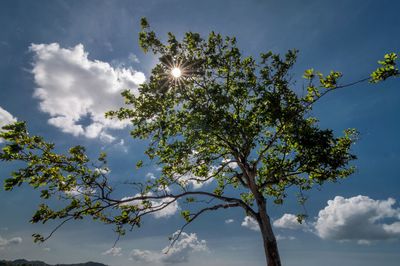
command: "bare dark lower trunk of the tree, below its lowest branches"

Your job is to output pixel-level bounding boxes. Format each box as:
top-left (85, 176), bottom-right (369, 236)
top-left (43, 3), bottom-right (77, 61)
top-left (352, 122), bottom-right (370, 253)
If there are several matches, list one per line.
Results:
top-left (258, 208), bottom-right (281, 266)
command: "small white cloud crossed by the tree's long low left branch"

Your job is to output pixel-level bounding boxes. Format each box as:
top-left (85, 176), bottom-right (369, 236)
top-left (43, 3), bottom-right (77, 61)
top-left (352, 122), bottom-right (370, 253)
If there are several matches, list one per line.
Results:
top-left (121, 192), bottom-right (180, 219)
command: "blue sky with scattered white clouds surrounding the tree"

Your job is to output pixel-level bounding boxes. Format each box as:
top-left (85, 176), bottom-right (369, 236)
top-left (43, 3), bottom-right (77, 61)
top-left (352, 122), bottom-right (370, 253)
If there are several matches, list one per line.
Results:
top-left (0, 0), bottom-right (400, 266)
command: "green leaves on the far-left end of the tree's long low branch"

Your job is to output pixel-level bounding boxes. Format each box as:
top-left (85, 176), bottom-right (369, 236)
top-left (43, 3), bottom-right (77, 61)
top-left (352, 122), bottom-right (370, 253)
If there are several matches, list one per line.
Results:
top-left (0, 122), bottom-right (134, 242)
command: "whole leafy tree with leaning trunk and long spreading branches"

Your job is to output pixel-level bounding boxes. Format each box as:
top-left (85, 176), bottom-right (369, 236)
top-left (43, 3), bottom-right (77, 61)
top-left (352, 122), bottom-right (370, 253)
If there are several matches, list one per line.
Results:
top-left (0, 19), bottom-right (400, 266)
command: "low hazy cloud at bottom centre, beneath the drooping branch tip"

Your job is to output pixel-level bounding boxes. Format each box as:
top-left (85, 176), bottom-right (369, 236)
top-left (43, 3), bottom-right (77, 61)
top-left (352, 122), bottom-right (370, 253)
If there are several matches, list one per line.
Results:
top-left (130, 231), bottom-right (208, 264)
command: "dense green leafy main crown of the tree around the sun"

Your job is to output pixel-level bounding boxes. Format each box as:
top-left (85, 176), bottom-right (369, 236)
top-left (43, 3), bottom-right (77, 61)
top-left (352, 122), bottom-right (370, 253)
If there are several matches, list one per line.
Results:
top-left (108, 18), bottom-right (355, 209)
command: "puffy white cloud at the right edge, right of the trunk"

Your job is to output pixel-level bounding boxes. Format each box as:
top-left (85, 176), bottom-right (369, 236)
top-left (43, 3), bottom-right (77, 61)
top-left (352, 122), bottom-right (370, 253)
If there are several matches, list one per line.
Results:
top-left (315, 195), bottom-right (400, 244)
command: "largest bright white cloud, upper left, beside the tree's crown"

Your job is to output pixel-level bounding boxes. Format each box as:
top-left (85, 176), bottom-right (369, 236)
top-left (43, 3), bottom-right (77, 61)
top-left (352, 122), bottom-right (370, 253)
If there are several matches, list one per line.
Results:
top-left (30, 43), bottom-right (145, 142)
